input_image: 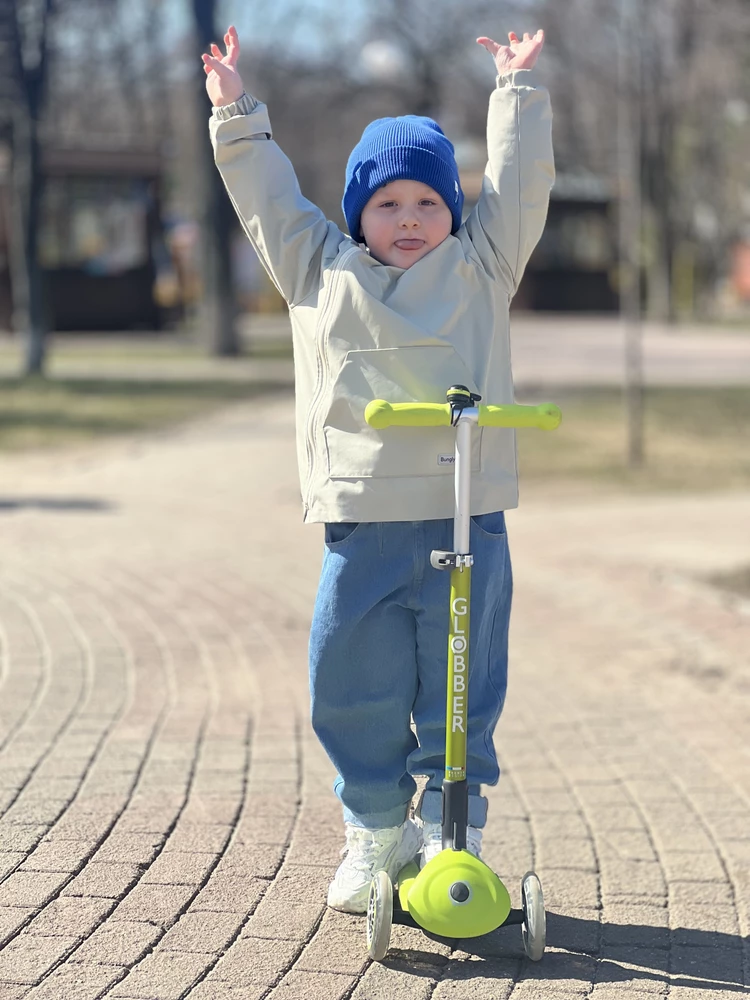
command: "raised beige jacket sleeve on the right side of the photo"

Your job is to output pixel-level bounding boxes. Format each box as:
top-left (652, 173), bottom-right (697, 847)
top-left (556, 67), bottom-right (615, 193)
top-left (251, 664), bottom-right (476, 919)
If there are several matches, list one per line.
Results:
top-left (465, 70), bottom-right (555, 296)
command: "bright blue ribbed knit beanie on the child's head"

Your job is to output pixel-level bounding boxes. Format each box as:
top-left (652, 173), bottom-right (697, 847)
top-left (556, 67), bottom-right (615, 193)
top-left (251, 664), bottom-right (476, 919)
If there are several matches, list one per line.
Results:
top-left (341, 115), bottom-right (464, 240)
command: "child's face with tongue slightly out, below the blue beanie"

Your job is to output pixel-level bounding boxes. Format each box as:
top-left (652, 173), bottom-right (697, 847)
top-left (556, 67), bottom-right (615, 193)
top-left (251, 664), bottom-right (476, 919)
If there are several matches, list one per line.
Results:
top-left (361, 181), bottom-right (453, 267)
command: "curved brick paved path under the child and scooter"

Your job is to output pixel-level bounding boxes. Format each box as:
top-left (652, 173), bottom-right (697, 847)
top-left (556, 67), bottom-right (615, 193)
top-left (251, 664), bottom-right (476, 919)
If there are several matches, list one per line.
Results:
top-left (0, 397), bottom-right (750, 1000)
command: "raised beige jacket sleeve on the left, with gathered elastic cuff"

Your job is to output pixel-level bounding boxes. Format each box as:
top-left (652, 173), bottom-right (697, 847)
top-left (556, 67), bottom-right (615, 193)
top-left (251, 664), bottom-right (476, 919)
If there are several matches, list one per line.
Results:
top-left (209, 94), bottom-right (346, 305)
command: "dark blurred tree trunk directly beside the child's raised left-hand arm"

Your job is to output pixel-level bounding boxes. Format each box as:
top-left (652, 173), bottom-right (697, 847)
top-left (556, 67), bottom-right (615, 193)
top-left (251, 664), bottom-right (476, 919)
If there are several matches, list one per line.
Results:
top-left (193, 0), bottom-right (239, 357)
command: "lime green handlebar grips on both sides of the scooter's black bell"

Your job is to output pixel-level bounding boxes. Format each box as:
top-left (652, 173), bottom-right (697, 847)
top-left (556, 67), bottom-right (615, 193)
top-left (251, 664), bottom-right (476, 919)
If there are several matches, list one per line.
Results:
top-left (365, 399), bottom-right (562, 431)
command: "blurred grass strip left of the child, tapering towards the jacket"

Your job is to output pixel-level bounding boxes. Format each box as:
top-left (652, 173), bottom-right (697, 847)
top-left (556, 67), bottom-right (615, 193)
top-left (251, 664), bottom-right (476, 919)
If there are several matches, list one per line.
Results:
top-left (0, 378), bottom-right (289, 452)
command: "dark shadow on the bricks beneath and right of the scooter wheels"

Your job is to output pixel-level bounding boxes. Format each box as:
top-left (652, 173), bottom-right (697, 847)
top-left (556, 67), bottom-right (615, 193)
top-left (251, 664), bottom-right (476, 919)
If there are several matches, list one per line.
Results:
top-left (384, 913), bottom-right (745, 994)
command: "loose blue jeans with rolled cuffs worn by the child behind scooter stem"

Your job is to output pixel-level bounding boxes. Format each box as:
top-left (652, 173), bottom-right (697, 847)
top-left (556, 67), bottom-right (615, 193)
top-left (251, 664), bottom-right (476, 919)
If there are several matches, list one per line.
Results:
top-left (310, 511), bottom-right (513, 829)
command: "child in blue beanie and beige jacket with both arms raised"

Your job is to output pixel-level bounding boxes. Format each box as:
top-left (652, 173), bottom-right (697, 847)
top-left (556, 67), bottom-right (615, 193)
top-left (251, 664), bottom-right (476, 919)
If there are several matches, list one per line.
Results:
top-left (203, 28), bottom-right (554, 913)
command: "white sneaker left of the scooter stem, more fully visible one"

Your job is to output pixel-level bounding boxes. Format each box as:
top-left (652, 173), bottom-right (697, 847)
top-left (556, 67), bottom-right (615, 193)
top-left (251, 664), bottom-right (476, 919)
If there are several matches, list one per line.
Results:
top-left (328, 820), bottom-right (422, 913)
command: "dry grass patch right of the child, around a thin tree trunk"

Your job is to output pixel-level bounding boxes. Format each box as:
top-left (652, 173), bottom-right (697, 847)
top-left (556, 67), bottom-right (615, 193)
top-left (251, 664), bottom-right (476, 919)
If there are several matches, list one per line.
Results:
top-left (518, 387), bottom-right (750, 492)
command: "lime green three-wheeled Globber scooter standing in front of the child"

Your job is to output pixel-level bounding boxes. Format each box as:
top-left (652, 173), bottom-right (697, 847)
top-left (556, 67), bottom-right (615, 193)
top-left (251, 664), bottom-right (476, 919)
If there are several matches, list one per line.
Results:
top-left (365, 385), bottom-right (561, 962)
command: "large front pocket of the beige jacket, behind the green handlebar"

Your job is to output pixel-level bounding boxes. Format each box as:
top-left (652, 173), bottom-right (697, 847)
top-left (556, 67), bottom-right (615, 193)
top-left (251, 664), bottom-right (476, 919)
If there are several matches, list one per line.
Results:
top-left (323, 344), bottom-right (482, 479)
